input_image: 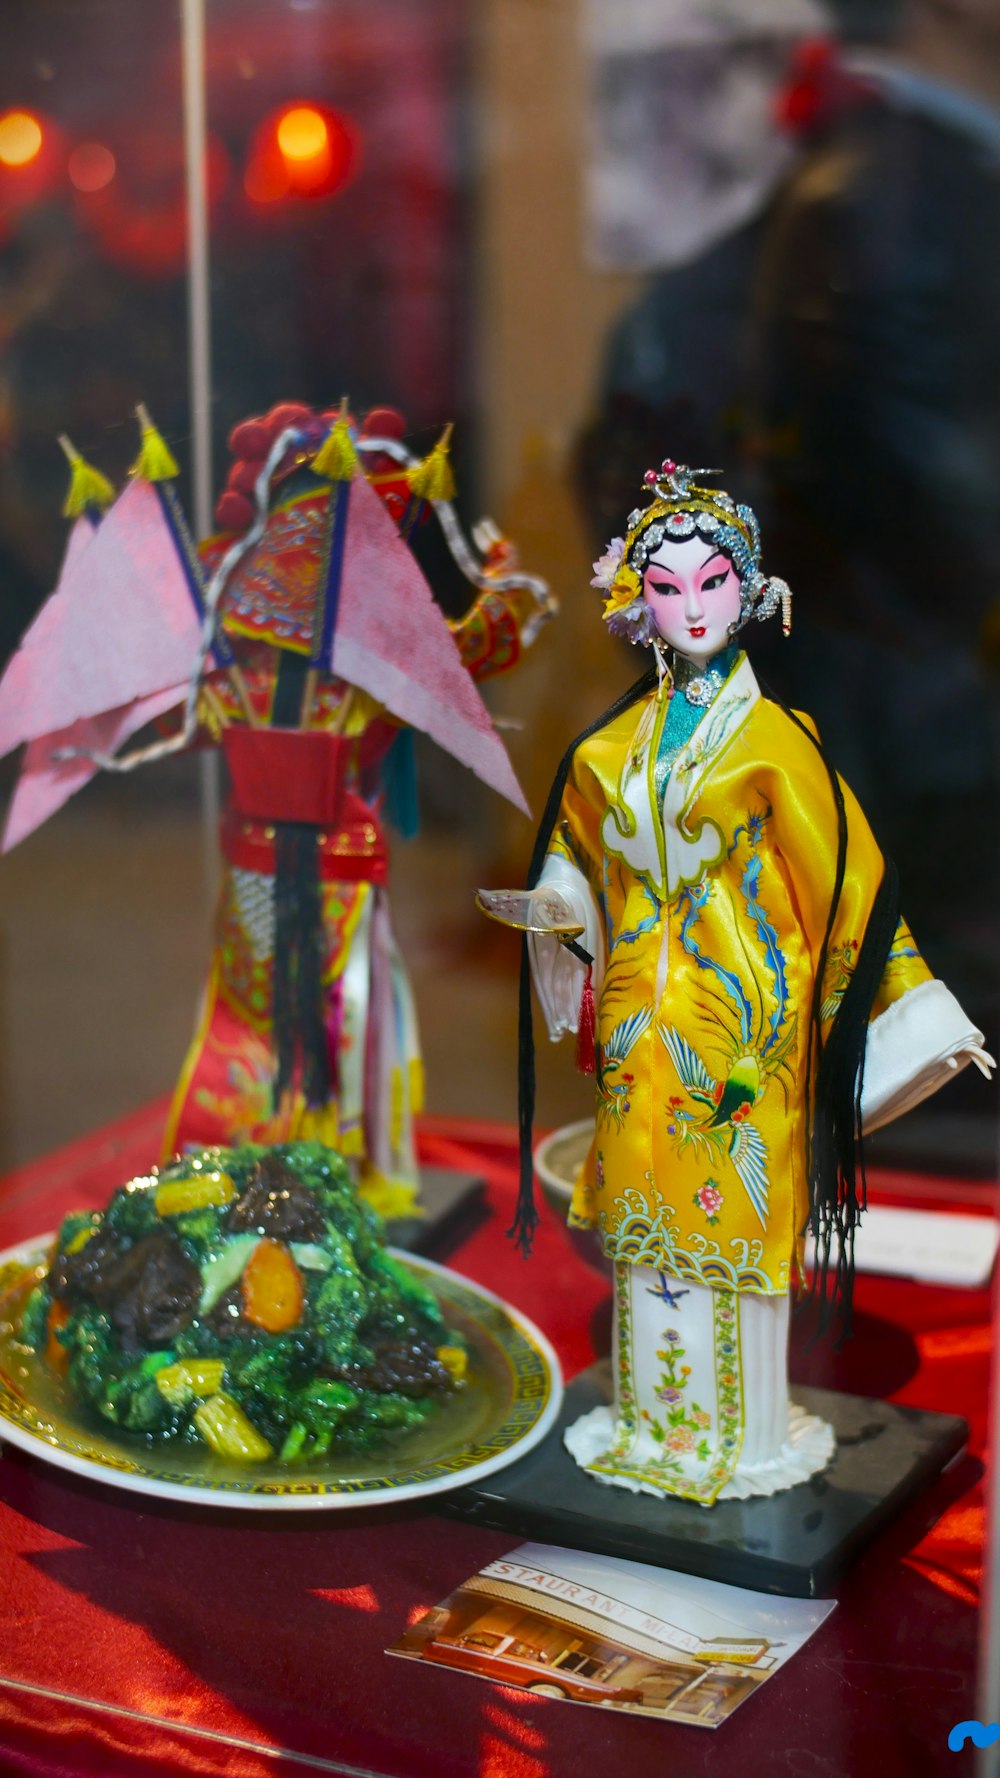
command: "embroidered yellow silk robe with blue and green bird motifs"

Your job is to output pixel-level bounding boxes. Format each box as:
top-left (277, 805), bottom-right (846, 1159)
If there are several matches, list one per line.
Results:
top-left (550, 656), bottom-right (931, 1294)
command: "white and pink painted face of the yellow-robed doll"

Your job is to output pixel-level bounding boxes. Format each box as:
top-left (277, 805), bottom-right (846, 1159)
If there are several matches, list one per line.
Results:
top-left (642, 535), bottom-right (740, 661)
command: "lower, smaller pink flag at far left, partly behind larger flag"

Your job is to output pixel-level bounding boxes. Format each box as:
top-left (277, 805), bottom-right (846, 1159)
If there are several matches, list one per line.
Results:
top-left (0, 685), bottom-right (187, 852)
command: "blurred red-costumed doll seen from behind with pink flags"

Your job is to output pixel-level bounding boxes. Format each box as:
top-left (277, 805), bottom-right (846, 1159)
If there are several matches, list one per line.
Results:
top-left (0, 400), bottom-right (555, 1218)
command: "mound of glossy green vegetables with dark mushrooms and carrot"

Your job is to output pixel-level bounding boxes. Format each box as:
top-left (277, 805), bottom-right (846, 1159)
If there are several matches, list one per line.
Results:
top-left (21, 1141), bottom-right (466, 1463)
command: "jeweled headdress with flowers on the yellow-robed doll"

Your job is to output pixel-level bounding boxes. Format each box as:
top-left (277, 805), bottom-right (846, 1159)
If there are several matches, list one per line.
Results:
top-left (591, 457), bottom-right (792, 642)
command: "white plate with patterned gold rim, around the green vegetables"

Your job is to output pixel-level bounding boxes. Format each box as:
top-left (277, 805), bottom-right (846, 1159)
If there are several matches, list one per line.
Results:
top-left (0, 1236), bottom-right (562, 1511)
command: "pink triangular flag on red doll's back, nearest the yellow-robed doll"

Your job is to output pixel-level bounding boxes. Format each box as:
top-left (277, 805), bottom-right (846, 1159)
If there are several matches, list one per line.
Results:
top-left (331, 475), bottom-right (528, 814)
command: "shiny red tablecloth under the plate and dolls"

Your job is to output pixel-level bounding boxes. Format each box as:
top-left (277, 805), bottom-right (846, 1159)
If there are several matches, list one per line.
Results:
top-left (0, 1104), bottom-right (991, 1778)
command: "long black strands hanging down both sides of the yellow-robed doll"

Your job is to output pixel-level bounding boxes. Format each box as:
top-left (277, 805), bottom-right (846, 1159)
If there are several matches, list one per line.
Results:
top-left (507, 672), bottom-right (899, 1339)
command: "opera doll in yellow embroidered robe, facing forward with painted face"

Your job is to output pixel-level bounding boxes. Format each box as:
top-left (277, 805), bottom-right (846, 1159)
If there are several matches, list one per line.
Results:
top-left (480, 461), bottom-right (991, 1506)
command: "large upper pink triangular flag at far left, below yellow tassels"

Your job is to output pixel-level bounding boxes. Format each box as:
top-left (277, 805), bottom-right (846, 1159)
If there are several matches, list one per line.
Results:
top-left (0, 480), bottom-right (201, 756)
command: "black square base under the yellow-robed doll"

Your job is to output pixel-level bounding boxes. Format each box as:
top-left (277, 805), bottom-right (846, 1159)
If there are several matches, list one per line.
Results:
top-left (441, 1360), bottom-right (968, 1598)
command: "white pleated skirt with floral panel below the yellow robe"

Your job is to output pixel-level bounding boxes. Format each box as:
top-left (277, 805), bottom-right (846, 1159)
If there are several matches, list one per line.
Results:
top-left (564, 1264), bottom-right (835, 1506)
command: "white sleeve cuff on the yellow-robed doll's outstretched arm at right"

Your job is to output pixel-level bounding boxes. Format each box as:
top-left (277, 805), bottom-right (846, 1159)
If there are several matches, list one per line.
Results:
top-left (861, 981), bottom-right (984, 1134)
